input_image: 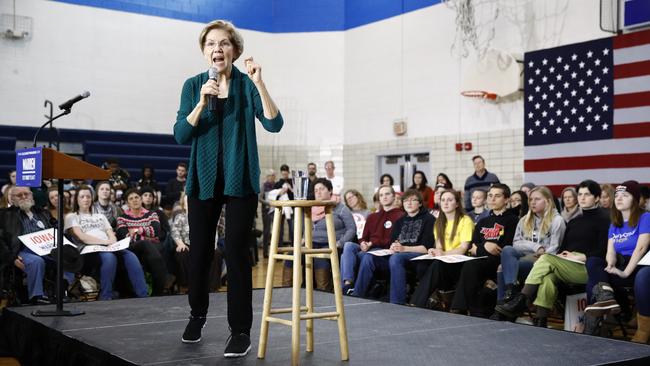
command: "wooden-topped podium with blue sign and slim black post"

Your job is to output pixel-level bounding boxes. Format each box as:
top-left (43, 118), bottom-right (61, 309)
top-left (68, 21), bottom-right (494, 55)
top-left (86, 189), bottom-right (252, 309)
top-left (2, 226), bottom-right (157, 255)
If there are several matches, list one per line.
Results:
top-left (16, 147), bottom-right (111, 316)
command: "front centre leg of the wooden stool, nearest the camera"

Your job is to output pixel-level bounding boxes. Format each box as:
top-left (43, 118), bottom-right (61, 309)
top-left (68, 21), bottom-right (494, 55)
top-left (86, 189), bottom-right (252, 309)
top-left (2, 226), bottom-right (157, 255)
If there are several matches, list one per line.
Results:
top-left (291, 207), bottom-right (302, 365)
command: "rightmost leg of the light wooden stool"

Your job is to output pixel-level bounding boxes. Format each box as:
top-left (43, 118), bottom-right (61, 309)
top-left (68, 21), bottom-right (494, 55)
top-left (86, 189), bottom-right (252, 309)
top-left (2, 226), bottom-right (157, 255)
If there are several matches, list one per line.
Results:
top-left (325, 206), bottom-right (349, 361)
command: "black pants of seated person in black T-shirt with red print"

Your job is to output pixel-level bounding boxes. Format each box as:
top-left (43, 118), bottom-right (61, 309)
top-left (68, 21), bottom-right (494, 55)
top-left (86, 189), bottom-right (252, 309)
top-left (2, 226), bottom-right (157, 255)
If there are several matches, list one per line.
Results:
top-left (451, 256), bottom-right (501, 311)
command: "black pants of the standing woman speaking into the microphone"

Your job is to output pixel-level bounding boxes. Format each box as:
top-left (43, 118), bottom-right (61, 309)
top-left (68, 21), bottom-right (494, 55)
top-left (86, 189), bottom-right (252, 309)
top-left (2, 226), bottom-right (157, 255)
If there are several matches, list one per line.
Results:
top-left (187, 190), bottom-right (257, 334)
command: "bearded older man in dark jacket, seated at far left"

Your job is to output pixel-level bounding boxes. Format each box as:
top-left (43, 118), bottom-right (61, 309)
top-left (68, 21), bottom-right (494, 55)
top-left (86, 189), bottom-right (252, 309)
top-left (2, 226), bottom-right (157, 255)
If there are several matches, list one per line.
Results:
top-left (0, 187), bottom-right (74, 304)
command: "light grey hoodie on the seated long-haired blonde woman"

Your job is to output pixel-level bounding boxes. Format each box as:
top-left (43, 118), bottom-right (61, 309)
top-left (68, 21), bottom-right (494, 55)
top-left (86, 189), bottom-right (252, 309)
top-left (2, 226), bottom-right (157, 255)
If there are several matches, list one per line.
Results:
top-left (512, 211), bottom-right (566, 254)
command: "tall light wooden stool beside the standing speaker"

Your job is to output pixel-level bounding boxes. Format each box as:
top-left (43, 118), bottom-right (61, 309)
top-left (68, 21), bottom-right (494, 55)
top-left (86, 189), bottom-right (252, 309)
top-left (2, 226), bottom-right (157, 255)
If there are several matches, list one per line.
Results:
top-left (257, 200), bottom-right (348, 365)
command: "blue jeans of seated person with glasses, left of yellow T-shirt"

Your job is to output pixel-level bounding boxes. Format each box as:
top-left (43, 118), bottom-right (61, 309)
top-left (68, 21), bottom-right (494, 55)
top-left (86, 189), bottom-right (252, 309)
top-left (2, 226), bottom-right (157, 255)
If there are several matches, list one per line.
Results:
top-left (354, 253), bottom-right (422, 304)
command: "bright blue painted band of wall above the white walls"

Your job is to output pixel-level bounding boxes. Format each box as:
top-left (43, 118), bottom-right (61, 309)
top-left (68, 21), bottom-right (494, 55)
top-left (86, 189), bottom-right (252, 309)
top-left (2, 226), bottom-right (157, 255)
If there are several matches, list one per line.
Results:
top-left (54, 0), bottom-right (441, 33)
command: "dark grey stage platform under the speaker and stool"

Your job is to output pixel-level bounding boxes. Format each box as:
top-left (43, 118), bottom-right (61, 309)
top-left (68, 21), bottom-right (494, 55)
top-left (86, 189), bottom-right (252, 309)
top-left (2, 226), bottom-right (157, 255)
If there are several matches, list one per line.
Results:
top-left (1, 288), bottom-right (650, 366)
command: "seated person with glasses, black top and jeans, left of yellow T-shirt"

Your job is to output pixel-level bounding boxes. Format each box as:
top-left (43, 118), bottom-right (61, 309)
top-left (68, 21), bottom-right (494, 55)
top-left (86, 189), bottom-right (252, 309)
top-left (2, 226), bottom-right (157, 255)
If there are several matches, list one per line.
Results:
top-left (352, 189), bottom-right (435, 304)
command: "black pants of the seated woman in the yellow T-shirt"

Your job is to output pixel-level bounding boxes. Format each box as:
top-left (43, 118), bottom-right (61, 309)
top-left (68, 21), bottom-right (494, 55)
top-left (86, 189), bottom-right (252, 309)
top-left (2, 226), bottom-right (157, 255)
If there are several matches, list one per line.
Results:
top-left (411, 260), bottom-right (463, 308)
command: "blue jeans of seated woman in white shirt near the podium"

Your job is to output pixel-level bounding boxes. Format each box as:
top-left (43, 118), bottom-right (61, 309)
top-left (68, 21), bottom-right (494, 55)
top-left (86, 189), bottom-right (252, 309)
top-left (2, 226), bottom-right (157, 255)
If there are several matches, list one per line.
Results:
top-left (98, 249), bottom-right (147, 300)
